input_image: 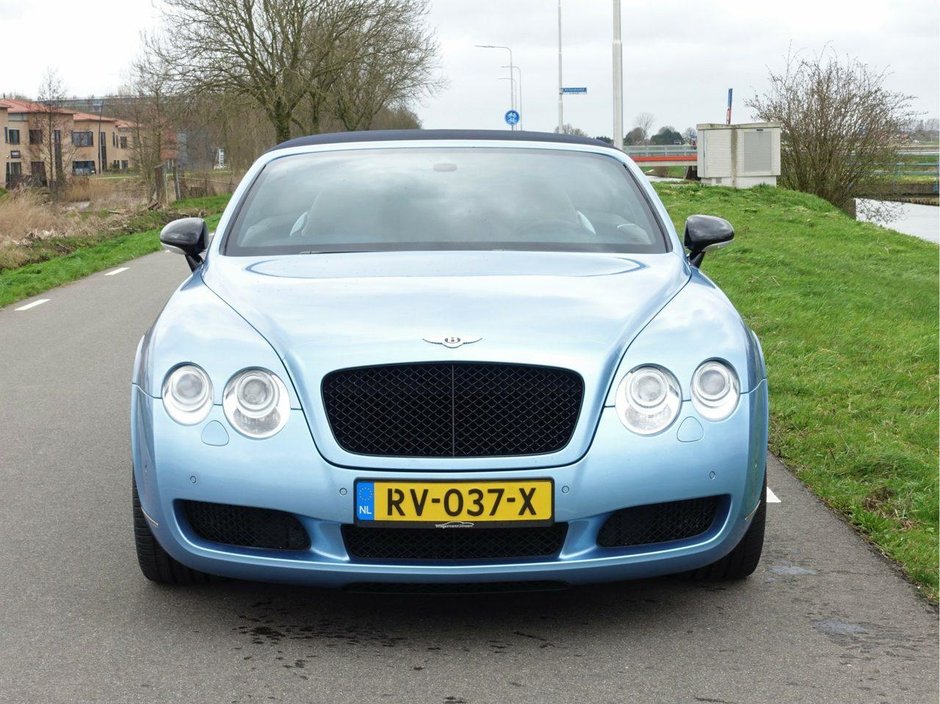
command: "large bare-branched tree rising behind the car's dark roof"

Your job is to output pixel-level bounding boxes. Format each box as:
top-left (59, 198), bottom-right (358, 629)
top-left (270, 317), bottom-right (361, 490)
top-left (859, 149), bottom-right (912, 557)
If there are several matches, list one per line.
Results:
top-left (147, 0), bottom-right (437, 141)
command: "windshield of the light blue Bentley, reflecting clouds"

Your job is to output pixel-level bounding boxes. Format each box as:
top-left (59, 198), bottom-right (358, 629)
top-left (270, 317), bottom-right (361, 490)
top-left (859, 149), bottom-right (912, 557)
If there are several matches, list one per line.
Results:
top-left (223, 147), bottom-right (668, 256)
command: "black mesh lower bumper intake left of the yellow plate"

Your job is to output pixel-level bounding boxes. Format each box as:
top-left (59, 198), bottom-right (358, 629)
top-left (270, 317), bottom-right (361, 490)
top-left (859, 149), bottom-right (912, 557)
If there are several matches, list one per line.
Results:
top-left (181, 501), bottom-right (310, 550)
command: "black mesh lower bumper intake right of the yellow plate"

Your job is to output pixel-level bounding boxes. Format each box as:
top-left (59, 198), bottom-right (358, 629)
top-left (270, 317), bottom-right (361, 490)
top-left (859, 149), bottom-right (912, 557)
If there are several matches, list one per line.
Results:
top-left (597, 496), bottom-right (721, 548)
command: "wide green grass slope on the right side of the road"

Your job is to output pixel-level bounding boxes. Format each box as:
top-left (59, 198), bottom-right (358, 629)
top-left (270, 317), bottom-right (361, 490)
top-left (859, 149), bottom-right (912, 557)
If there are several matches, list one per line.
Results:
top-left (655, 183), bottom-right (938, 601)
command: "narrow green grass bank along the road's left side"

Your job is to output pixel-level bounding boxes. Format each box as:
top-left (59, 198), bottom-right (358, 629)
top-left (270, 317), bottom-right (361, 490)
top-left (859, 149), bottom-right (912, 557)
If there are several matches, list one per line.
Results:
top-left (0, 196), bottom-right (229, 307)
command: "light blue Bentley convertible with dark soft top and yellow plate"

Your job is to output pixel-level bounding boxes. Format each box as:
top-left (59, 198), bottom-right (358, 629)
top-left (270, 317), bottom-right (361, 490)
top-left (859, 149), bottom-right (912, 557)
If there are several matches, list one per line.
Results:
top-left (131, 131), bottom-right (767, 588)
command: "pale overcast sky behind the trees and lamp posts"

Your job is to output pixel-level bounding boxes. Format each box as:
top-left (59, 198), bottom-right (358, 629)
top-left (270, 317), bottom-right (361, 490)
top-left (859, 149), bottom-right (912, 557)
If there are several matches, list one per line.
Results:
top-left (0, 0), bottom-right (940, 135)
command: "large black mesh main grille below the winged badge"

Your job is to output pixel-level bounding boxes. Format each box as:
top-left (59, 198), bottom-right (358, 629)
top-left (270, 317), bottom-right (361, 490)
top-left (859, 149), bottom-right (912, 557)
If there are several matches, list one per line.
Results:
top-left (323, 363), bottom-right (584, 457)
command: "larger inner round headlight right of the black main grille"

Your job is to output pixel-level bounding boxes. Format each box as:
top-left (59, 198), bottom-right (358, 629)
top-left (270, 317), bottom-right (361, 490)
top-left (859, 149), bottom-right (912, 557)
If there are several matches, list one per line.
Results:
top-left (617, 367), bottom-right (682, 435)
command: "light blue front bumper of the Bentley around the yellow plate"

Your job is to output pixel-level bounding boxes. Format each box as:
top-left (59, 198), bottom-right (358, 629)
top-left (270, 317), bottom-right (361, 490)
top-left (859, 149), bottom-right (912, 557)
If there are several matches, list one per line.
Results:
top-left (131, 382), bottom-right (767, 587)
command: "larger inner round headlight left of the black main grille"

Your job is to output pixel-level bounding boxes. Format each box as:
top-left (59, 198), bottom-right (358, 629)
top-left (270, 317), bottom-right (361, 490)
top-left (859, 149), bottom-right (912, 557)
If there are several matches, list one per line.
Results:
top-left (222, 369), bottom-right (290, 438)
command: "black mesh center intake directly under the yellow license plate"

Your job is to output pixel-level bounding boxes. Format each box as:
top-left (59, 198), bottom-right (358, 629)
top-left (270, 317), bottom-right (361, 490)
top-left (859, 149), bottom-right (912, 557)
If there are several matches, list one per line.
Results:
top-left (343, 523), bottom-right (568, 560)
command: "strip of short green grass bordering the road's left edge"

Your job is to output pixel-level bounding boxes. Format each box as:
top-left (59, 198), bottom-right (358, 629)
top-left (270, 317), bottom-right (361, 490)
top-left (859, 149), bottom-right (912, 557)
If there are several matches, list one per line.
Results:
top-left (0, 196), bottom-right (228, 307)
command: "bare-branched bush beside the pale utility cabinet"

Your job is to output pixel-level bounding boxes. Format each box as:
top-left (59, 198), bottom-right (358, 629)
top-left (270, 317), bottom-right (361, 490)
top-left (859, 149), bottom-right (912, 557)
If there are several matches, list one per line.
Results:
top-left (745, 48), bottom-right (913, 210)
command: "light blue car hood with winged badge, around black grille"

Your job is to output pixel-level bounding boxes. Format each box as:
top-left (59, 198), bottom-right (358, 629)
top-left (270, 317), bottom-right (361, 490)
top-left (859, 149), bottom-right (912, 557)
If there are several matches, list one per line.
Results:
top-left (204, 252), bottom-right (690, 467)
